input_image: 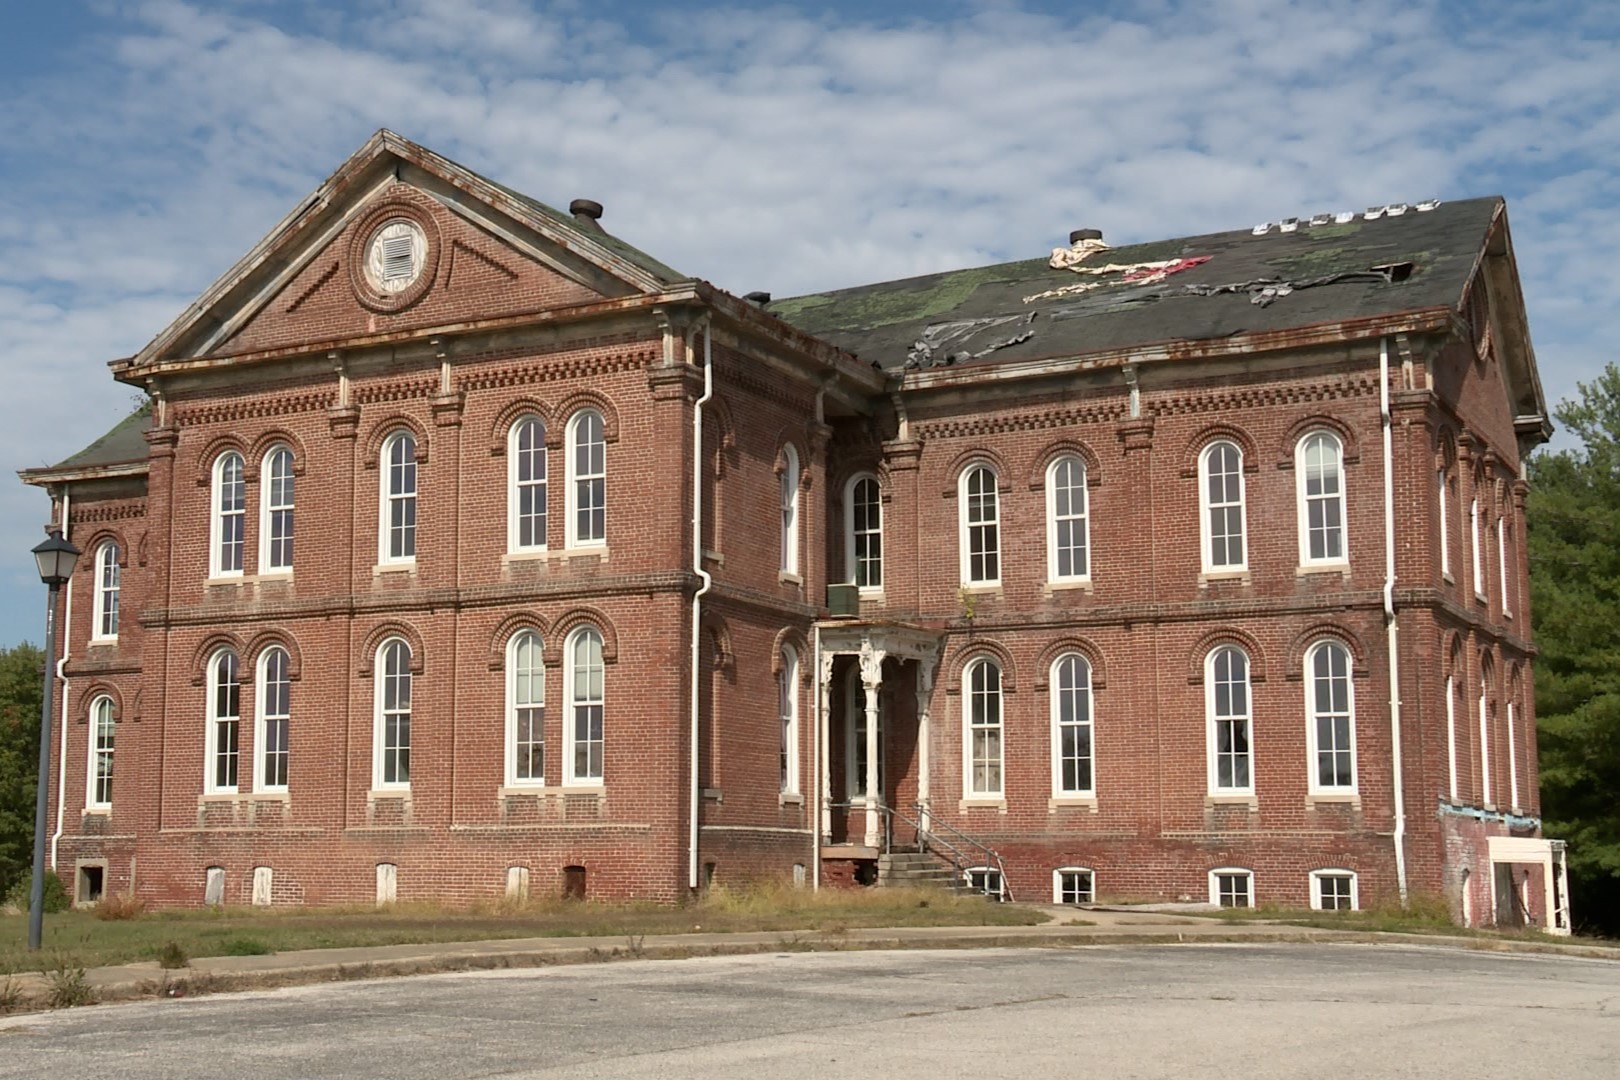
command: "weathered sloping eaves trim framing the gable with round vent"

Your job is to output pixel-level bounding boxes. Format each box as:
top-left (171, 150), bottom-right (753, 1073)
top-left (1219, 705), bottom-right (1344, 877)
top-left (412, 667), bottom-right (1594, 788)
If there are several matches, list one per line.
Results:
top-left (113, 128), bottom-right (692, 372)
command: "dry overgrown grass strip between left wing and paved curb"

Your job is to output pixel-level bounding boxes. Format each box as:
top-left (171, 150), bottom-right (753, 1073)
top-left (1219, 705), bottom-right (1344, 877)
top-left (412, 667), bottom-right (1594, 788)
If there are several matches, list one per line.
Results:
top-left (0, 886), bottom-right (1043, 972)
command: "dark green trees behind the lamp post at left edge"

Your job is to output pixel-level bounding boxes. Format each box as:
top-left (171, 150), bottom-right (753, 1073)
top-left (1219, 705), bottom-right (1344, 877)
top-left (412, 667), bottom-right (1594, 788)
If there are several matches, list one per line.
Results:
top-left (0, 643), bottom-right (45, 897)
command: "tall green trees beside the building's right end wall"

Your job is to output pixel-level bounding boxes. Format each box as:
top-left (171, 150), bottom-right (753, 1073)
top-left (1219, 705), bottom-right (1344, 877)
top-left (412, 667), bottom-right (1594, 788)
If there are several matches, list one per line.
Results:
top-left (1528, 364), bottom-right (1620, 933)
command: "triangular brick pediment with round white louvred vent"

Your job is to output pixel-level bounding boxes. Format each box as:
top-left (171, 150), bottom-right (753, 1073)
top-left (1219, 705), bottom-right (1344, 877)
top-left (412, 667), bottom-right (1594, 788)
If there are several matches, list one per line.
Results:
top-left (130, 131), bottom-right (679, 369)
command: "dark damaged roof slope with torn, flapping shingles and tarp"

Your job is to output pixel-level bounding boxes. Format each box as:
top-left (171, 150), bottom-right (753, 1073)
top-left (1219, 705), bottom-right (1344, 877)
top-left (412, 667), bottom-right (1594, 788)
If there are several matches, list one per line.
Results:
top-left (770, 196), bottom-right (1502, 371)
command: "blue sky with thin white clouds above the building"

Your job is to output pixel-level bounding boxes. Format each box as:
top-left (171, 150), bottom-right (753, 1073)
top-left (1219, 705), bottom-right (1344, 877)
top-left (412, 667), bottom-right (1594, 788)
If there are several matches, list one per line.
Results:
top-left (0, 0), bottom-right (1620, 644)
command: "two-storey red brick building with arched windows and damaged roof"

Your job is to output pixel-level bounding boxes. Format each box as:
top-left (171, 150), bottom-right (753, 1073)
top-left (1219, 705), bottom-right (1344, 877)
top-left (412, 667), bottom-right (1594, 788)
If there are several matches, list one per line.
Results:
top-left (23, 131), bottom-right (1568, 928)
